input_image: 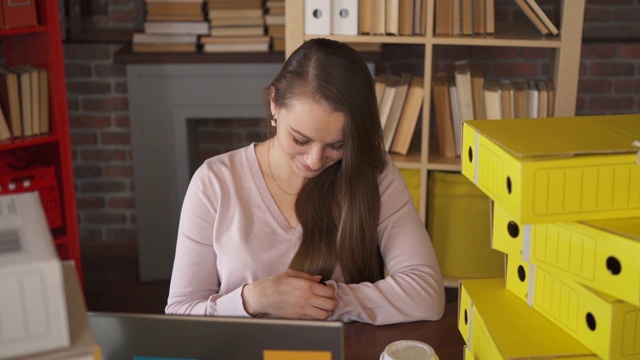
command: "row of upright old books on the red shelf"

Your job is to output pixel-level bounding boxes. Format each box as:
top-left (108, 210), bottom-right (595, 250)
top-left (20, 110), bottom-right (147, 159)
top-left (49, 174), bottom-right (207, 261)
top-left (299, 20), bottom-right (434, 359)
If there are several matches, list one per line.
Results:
top-left (0, 66), bottom-right (49, 140)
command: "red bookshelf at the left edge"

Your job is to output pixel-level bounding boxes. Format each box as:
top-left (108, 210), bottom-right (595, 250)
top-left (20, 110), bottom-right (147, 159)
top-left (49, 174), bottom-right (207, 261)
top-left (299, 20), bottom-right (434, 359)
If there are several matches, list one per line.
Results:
top-left (0, 0), bottom-right (82, 279)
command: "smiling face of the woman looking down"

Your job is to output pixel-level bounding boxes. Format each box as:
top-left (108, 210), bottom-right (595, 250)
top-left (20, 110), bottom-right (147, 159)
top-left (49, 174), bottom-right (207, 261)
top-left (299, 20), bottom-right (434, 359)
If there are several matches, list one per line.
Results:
top-left (271, 98), bottom-right (347, 178)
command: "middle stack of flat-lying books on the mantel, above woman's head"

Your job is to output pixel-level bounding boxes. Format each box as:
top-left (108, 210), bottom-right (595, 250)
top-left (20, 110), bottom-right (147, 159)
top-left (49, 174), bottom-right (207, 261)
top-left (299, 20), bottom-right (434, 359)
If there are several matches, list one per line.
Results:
top-left (200, 0), bottom-right (270, 52)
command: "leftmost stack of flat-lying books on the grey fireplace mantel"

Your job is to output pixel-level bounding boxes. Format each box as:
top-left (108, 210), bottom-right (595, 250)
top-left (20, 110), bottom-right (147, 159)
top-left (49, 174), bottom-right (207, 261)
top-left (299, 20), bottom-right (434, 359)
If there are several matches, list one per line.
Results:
top-left (132, 0), bottom-right (209, 52)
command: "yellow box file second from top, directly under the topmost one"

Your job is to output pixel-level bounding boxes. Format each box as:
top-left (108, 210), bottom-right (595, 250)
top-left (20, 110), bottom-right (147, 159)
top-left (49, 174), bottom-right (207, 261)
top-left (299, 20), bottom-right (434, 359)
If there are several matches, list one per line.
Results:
top-left (492, 204), bottom-right (640, 306)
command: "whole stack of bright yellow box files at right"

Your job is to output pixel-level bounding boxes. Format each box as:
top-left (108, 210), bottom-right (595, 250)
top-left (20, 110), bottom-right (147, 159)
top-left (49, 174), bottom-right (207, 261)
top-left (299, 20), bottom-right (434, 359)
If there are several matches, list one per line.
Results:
top-left (459, 114), bottom-right (640, 360)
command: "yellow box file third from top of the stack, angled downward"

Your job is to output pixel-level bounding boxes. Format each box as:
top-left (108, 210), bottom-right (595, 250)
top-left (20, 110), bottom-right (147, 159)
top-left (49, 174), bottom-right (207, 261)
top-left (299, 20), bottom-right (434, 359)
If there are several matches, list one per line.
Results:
top-left (507, 256), bottom-right (640, 360)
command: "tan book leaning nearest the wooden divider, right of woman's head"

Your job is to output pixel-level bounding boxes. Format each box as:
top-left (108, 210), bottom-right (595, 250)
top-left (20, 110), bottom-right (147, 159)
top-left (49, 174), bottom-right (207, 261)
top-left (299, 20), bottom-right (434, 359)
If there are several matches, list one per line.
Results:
top-left (390, 76), bottom-right (424, 155)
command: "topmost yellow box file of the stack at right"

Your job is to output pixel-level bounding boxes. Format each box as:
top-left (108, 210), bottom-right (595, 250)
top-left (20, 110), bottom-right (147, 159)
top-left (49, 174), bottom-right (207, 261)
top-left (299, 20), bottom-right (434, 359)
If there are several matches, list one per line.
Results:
top-left (462, 114), bottom-right (640, 223)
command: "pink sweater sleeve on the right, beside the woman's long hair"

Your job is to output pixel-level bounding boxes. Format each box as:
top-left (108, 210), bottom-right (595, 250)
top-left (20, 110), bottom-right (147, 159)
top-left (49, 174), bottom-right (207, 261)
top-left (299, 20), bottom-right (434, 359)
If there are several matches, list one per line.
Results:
top-left (331, 160), bottom-right (445, 325)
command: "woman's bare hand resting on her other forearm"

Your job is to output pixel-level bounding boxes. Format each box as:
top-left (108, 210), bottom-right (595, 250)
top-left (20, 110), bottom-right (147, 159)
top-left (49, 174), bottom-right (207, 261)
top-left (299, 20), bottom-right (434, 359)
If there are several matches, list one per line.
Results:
top-left (242, 269), bottom-right (338, 320)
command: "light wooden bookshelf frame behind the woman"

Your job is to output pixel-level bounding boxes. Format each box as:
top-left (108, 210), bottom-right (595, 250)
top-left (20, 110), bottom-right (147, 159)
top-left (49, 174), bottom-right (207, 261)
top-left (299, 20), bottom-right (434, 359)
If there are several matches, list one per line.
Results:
top-left (285, 0), bottom-right (585, 223)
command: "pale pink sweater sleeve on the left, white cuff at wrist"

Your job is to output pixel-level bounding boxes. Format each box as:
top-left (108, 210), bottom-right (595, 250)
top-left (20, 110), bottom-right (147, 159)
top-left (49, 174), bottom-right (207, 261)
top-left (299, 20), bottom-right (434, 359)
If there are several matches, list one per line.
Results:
top-left (165, 162), bottom-right (249, 316)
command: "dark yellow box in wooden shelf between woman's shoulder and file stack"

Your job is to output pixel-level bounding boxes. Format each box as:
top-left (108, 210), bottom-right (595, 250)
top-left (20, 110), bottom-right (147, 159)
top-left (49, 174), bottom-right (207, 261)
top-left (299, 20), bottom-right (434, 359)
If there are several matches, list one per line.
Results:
top-left (427, 171), bottom-right (505, 286)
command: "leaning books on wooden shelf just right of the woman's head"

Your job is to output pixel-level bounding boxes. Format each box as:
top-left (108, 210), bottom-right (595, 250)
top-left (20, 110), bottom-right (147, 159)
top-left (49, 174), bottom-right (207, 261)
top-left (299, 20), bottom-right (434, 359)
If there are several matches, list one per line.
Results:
top-left (375, 73), bottom-right (424, 155)
